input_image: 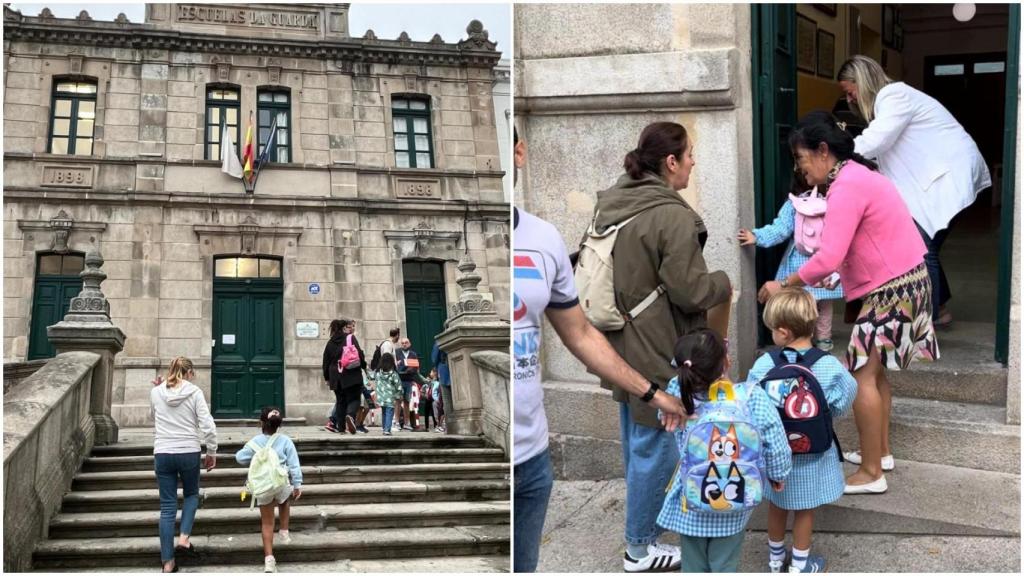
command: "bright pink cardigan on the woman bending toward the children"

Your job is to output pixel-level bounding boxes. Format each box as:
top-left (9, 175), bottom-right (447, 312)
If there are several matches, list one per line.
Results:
top-left (798, 161), bottom-right (928, 300)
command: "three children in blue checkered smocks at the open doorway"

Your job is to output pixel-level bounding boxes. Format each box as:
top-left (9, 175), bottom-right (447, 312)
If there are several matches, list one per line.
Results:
top-left (657, 174), bottom-right (857, 573)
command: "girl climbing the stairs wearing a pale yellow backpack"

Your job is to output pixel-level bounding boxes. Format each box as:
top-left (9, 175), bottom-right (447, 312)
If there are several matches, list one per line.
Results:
top-left (234, 406), bottom-right (302, 572)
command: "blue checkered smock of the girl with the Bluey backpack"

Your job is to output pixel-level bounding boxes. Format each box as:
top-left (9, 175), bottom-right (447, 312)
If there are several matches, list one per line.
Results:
top-left (657, 377), bottom-right (793, 538)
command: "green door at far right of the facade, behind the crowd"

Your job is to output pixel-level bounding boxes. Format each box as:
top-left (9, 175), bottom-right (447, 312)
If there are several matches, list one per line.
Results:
top-left (402, 261), bottom-right (447, 376)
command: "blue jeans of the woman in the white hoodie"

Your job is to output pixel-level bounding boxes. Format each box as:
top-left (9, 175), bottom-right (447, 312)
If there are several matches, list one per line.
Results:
top-left (154, 452), bottom-right (200, 562)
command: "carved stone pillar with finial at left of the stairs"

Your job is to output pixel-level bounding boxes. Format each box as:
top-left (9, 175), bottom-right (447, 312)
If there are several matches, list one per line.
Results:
top-left (46, 248), bottom-right (125, 445)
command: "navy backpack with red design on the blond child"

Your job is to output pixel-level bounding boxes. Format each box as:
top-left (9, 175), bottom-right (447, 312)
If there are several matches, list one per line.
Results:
top-left (759, 347), bottom-right (843, 461)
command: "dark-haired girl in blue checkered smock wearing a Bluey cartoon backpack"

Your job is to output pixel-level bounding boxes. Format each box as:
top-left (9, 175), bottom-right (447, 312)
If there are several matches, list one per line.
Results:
top-left (657, 328), bottom-right (793, 572)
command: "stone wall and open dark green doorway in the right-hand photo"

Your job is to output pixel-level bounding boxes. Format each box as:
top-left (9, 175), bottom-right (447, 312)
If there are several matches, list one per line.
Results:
top-left (514, 3), bottom-right (1020, 480)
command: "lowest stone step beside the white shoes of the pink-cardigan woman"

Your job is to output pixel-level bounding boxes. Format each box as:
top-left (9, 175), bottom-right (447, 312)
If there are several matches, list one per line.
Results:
top-left (836, 398), bottom-right (1021, 474)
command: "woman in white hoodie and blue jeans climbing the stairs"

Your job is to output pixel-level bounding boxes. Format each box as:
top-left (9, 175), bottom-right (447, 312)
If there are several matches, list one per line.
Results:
top-left (150, 356), bottom-right (217, 572)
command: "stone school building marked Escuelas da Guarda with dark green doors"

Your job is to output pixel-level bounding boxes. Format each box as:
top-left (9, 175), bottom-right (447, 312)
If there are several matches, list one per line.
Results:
top-left (3, 4), bottom-right (509, 426)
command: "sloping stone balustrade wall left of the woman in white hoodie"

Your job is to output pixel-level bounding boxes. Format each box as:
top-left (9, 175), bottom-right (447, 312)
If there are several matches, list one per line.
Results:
top-left (3, 352), bottom-right (100, 572)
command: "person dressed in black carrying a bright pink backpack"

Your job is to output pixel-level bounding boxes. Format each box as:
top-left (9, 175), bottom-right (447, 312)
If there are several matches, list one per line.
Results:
top-left (324, 320), bottom-right (367, 434)
